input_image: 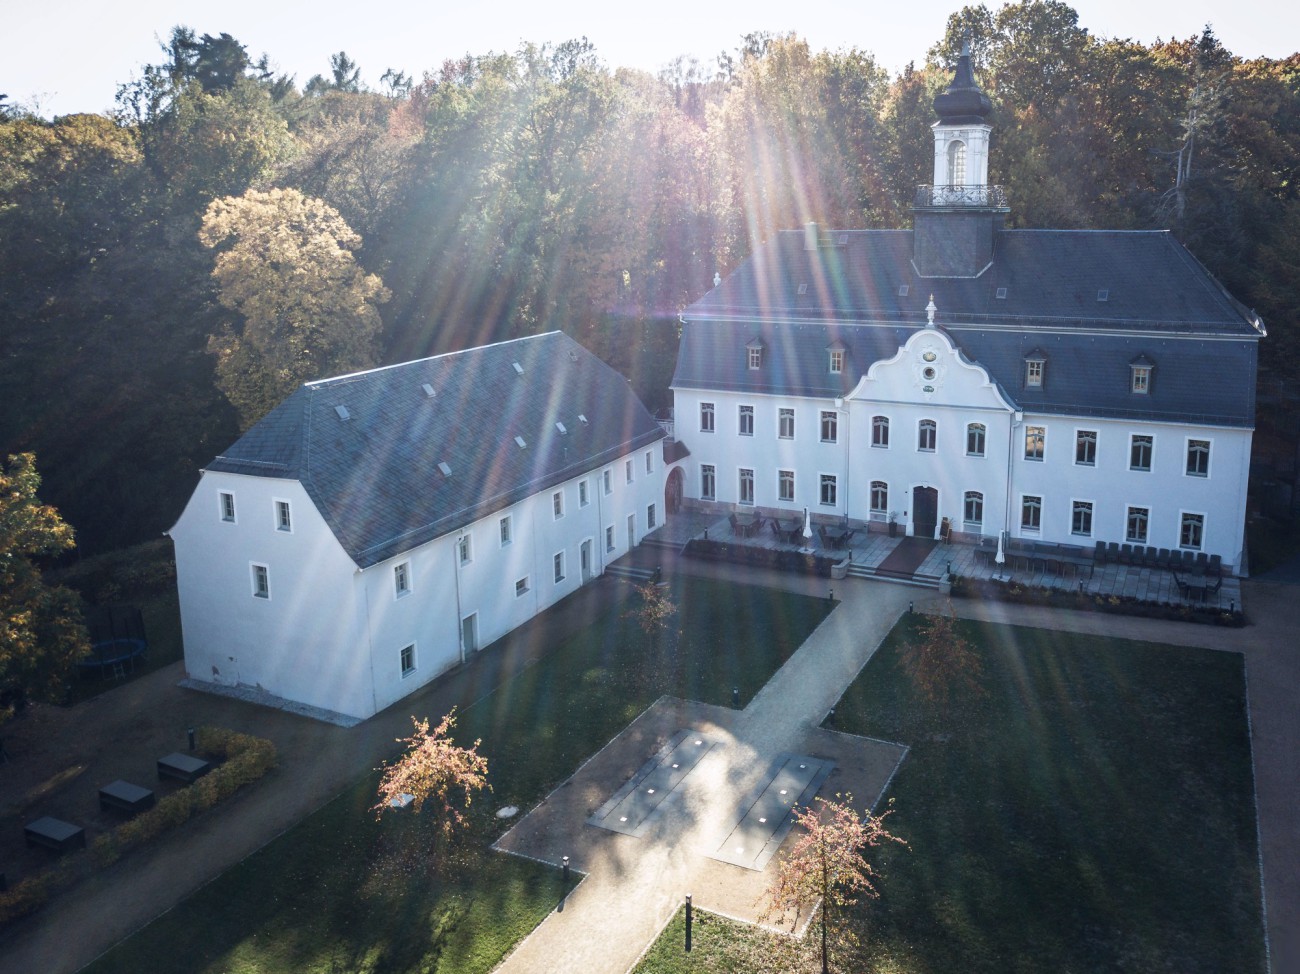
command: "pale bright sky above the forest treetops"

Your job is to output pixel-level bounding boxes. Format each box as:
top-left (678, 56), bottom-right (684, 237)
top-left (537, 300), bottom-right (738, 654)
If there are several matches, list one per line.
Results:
top-left (0, 0), bottom-right (1300, 117)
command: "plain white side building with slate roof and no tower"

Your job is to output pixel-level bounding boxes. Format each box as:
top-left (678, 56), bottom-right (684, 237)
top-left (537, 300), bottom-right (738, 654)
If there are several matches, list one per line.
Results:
top-left (170, 332), bottom-right (664, 719)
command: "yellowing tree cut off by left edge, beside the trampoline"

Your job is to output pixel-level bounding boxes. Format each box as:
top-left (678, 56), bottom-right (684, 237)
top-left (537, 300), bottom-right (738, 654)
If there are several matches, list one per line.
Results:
top-left (0, 453), bottom-right (90, 723)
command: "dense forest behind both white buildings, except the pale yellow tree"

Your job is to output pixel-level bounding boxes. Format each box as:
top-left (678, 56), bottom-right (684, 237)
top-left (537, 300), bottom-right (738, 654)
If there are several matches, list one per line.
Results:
top-left (0, 7), bottom-right (1300, 559)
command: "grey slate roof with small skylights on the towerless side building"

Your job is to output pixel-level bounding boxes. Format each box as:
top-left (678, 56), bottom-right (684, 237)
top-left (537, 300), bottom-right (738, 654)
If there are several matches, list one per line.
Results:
top-left (208, 332), bottom-right (664, 568)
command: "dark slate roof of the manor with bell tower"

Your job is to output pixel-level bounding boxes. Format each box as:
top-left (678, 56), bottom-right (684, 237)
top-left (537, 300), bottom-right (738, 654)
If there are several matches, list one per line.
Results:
top-left (673, 230), bottom-right (1264, 427)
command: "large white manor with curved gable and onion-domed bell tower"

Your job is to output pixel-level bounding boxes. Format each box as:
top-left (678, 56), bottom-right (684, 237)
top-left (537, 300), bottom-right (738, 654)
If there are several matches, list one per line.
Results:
top-left (670, 47), bottom-right (1265, 567)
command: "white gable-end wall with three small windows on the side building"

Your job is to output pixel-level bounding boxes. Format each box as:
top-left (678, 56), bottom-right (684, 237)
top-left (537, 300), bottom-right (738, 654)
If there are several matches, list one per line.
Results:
top-left (170, 472), bottom-right (374, 717)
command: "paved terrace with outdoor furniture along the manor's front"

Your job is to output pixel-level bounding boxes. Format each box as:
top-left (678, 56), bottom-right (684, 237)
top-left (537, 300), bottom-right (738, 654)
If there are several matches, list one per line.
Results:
top-left (647, 510), bottom-right (1243, 610)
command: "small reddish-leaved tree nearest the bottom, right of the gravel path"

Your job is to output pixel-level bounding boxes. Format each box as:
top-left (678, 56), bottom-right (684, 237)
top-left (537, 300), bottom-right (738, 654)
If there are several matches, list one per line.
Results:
top-left (759, 795), bottom-right (906, 974)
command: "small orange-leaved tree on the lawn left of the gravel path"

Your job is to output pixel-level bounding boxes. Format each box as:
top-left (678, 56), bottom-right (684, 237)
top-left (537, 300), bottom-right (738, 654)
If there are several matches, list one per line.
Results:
top-left (372, 707), bottom-right (491, 867)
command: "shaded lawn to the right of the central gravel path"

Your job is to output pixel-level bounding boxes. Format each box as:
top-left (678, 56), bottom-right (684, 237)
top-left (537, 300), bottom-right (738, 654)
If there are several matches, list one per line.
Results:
top-left (638, 616), bottom-right (1265, 974)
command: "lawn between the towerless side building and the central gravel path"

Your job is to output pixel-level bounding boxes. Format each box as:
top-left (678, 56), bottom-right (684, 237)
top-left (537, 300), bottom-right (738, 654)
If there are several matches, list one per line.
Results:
top-left (87, 579), bottom-right (831, 974)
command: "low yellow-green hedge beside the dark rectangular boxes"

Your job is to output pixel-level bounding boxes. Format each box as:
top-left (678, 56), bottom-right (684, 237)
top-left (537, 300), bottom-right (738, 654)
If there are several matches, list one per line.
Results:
top-left (0, 727), bottom-right (276, 925)
